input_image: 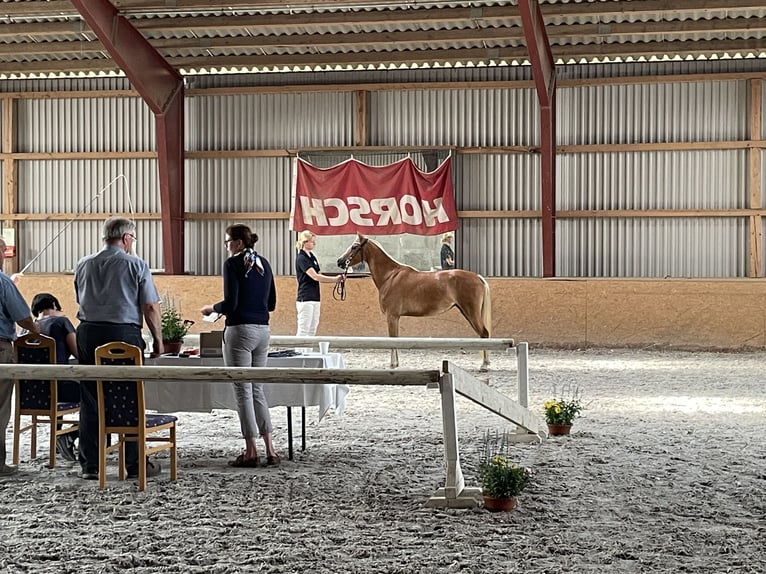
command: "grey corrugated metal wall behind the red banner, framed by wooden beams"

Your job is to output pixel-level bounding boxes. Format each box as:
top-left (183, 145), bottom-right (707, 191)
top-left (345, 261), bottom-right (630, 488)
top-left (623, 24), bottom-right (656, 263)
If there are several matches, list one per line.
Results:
top-left (0, 61), bottom-right (766, 277)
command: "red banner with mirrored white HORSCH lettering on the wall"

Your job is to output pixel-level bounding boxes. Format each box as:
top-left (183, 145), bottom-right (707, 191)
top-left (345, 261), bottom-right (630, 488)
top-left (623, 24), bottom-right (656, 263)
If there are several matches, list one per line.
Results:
top-left (290, 158), bottom-right (457, 235)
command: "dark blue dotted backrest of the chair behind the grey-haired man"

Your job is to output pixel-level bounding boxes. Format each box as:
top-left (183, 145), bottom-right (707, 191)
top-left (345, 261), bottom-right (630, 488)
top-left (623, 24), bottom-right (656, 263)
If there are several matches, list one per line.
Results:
top-left (96, 342), bottom-right (145, 427)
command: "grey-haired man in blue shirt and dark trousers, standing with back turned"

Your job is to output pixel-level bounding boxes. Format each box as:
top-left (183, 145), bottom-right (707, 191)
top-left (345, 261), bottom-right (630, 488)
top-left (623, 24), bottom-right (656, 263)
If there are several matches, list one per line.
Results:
top-left (74, 217), bottom-right (163, 480)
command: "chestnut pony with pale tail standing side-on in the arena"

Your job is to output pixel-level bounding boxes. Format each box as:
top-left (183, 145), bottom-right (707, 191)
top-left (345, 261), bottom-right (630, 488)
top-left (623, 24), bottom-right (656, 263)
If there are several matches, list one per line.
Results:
top-left (338, 234), bottom-right (492, 370)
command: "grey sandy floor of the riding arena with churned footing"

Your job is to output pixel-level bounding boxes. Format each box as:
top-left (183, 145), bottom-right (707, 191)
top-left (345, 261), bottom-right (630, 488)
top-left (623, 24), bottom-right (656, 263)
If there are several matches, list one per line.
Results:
top-left (0, 349), bottom-right (766, 574)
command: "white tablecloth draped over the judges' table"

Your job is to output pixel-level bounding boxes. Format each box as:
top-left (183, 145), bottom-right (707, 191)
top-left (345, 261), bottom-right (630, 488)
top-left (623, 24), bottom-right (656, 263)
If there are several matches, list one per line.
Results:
top-left (144, 353), bottom-right (349, 420)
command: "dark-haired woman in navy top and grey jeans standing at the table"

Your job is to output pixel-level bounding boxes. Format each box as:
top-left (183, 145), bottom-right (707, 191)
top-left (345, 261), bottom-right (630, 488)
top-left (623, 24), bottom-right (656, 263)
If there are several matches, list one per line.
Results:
top-left (201, 224), bottom-right (280, 467)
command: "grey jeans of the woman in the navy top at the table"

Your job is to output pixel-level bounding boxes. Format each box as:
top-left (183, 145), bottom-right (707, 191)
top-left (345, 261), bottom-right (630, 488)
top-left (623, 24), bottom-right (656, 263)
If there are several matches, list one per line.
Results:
top-left (223, 325), bottom-right (272, 438)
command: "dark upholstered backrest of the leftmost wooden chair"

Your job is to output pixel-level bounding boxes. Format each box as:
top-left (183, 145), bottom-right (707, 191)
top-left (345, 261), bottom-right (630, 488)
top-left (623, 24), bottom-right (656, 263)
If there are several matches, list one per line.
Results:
top-left (13, 333), bottom-right (56, 410)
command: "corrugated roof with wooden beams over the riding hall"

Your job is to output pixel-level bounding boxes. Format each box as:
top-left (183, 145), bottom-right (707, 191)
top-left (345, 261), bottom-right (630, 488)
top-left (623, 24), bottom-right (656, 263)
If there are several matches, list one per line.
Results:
top-left (0, 0), bottom-right (766, 78)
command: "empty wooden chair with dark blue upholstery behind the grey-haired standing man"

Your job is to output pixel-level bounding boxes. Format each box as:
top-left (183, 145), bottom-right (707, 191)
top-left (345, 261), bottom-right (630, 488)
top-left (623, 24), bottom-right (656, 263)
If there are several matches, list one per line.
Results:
top-left (96, 343), bottom-right (178, 490)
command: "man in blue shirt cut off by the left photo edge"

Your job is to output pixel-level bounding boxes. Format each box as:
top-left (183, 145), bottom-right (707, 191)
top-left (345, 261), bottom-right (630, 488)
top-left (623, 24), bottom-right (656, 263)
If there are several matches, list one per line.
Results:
top-left (0, 238), bottom-right (40, 476)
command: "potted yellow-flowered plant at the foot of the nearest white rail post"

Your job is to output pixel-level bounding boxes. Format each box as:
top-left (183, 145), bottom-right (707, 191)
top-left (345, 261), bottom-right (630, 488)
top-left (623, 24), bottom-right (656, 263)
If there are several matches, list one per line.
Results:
top-left (479, 432), bottom-right (530, 512)
